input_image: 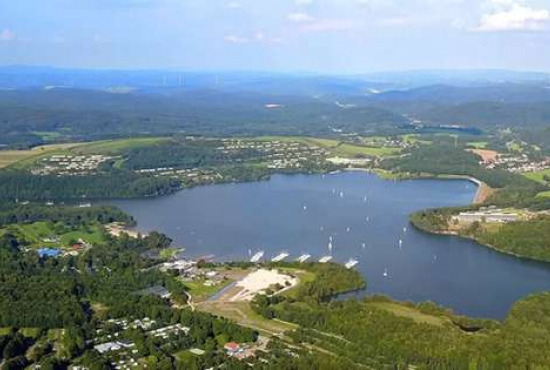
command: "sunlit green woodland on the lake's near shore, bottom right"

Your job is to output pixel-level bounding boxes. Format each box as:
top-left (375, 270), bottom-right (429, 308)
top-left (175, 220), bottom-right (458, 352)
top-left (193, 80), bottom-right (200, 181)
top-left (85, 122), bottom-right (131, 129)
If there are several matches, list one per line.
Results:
top-left (253, 258), bottom-right (550, 370)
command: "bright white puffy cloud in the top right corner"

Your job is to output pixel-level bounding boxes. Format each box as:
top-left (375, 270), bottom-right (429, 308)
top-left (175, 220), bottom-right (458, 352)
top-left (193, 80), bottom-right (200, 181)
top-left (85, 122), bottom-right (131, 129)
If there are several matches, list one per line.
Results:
top-left (475, 0), bottom-right (550, 32)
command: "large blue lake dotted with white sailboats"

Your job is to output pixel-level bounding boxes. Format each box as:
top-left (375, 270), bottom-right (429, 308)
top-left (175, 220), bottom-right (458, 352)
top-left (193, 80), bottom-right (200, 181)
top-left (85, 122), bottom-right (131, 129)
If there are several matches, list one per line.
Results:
top-left (109, 172), bottom-right (550, 319)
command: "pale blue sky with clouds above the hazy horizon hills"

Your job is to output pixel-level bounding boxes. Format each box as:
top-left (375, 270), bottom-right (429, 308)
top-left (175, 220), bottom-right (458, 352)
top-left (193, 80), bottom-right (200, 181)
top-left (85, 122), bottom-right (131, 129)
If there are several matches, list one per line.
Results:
top-left (0, 0), bottom-right (550, 74)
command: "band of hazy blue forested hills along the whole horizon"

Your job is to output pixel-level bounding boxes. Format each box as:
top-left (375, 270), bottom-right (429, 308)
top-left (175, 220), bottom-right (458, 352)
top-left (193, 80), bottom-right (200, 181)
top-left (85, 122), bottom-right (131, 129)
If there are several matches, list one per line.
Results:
top-left (0, 67), bottom-right (550, 147)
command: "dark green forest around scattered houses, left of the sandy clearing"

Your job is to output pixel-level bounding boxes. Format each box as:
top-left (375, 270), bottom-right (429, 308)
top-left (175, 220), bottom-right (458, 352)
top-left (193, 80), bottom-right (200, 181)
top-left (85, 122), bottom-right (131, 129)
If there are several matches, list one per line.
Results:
top-left (0, 233), bottom-right (266, 369)
